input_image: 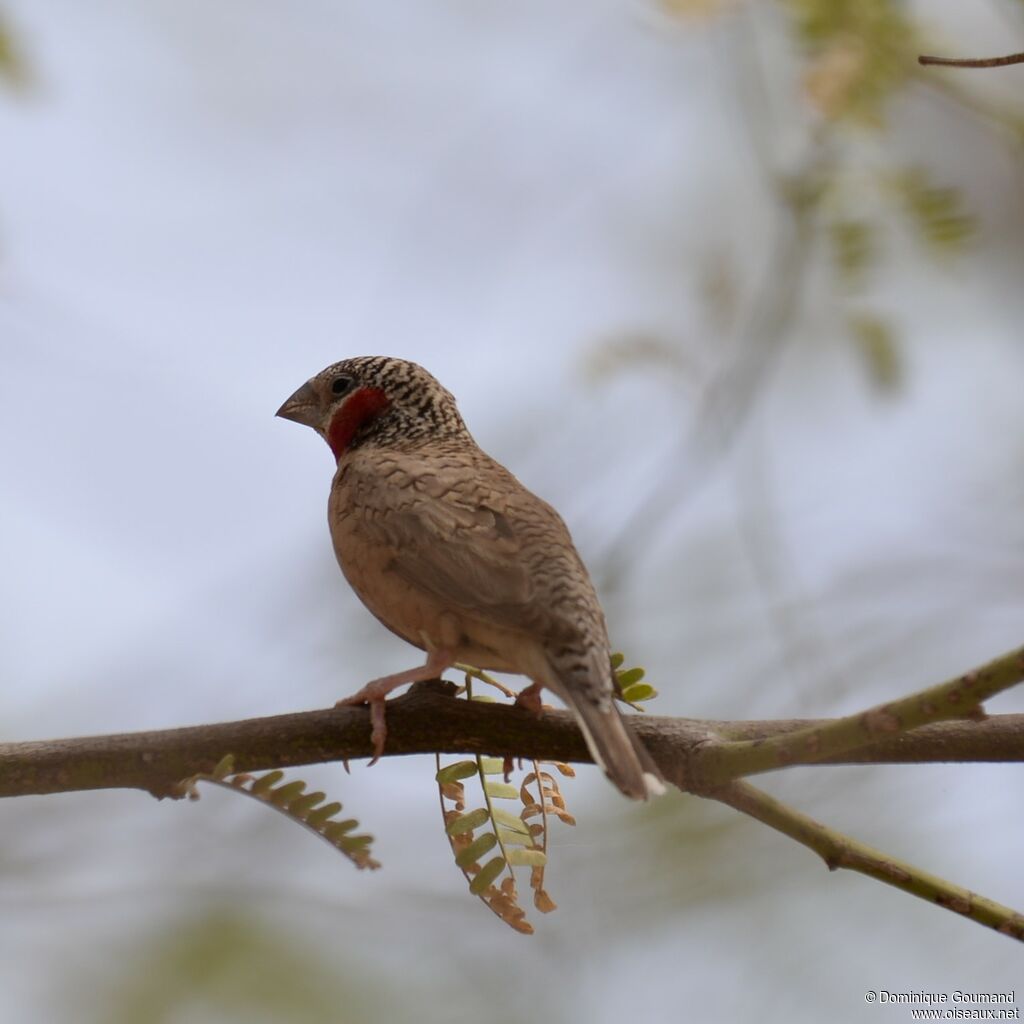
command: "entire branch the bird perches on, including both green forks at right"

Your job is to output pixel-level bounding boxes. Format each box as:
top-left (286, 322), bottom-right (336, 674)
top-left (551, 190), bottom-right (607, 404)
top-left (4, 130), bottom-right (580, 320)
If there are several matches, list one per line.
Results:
top-left (0, 648), bottom-right (1024, 941)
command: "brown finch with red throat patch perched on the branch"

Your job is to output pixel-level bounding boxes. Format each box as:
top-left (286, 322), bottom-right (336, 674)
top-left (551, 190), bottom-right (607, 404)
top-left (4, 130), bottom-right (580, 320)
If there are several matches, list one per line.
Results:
top-left (276, 355), bottom-right (665, 800)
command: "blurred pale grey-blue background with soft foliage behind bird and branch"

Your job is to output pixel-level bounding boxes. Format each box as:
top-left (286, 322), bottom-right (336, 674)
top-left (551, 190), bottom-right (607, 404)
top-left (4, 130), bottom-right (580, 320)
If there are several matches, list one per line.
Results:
top-left (0, 0), bottom-right (1024, 1022)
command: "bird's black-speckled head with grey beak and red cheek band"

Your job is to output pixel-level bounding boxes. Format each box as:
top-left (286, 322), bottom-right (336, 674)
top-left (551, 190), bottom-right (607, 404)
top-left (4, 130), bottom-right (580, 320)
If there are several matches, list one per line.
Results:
top-left (278, 355), bottom-right (466, 459)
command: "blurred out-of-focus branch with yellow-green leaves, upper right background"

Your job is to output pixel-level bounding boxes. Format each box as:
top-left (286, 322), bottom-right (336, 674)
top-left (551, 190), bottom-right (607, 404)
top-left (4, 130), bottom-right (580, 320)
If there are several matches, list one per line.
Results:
top-left (592, 0), bottom-right (1024, 586)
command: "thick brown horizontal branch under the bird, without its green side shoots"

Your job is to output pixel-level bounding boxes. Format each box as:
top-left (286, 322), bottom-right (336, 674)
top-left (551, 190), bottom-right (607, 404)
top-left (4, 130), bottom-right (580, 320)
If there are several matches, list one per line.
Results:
top-left (0, 682), bottom-right (1024, 797)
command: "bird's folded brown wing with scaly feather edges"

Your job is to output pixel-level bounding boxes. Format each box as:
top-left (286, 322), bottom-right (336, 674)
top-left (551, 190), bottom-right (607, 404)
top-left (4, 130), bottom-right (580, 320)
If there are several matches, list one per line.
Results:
top-left (349, 453), bottom-right (582, 630)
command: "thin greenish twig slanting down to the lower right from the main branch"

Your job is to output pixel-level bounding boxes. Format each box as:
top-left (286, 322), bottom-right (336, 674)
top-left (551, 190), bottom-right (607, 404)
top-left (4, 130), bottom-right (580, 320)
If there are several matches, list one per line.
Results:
top-left (708, 782), bottom-right (1024, 942)
